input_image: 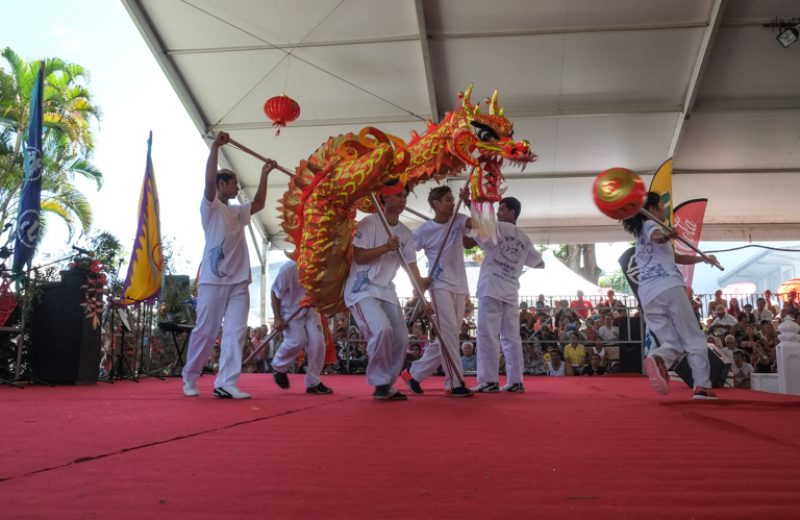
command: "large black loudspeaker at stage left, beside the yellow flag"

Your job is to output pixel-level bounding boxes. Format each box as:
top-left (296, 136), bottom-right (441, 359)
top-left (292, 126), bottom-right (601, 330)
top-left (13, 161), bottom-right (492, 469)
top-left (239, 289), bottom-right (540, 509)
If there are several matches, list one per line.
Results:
top-left (30, 270), bottom-right (100, 384)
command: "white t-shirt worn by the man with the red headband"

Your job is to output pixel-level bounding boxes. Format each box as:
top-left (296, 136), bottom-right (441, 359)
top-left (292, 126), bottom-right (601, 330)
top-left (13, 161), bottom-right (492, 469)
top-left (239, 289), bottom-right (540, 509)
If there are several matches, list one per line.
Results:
top-left (344, 214), bottom-right (417, 307)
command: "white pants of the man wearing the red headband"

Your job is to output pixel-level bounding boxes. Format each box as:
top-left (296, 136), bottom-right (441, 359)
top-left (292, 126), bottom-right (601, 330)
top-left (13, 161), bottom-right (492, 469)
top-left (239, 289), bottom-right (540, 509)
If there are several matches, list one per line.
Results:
top-left (350, 297), bottom-right (408, 386)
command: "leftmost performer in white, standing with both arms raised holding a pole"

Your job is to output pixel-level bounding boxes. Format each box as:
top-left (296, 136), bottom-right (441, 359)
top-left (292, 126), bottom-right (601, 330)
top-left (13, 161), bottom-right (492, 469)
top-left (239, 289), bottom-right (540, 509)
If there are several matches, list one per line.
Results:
top-left (182, 132), bottom-right (276, 399)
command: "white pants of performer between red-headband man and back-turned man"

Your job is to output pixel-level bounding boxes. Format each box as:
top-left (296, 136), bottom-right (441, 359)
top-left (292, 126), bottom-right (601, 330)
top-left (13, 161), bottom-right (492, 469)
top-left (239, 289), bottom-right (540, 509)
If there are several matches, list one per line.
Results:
top-left (409, 289), bottom-right (467, 388)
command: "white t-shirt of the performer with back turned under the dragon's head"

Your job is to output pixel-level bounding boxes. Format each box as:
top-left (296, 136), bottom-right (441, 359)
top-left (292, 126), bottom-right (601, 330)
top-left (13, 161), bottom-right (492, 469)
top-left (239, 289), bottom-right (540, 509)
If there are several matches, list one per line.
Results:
top-left (475, 222), bottom-right (542, 305)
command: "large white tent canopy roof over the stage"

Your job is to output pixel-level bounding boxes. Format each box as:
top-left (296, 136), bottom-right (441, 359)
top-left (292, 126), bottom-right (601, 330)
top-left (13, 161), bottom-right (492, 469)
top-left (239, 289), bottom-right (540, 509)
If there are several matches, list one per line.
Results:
top-left (122, 0), bottom-right (800, 247)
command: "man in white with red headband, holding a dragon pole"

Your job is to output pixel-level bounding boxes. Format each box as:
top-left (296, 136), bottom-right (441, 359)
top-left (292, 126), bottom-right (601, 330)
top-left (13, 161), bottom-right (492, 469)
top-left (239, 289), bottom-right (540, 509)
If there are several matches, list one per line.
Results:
top-left (344, 182), bottom-right (429, 401)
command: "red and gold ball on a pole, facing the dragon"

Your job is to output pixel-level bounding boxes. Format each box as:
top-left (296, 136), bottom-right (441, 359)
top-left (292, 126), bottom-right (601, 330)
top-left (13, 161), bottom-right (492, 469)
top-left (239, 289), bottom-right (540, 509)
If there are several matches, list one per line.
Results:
top-left (592, 168), bottom-right (647, 220)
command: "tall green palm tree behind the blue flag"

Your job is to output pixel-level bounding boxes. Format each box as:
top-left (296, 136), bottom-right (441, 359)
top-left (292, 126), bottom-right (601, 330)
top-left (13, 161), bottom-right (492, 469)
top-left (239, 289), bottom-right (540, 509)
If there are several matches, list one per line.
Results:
top-left (0, 47), bottom-right (103, 243)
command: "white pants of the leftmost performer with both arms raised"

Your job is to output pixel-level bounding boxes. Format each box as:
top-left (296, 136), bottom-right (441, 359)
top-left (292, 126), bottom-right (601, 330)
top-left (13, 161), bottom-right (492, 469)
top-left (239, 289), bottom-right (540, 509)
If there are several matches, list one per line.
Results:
top-left (181, 282), bottom-right (250, 388)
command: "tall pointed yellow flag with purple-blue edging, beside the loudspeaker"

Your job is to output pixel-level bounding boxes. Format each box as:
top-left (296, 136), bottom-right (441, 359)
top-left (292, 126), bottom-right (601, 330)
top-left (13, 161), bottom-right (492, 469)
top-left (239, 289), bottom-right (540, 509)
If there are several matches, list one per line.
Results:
top-left (121, 132), bottom-right (163, 305)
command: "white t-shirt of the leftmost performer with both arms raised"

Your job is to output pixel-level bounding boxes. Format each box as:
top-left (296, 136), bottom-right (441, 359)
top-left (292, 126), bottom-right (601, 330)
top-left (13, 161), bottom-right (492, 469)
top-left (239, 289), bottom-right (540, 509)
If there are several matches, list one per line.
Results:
top-left (198, 197), bottom-right (251, 285)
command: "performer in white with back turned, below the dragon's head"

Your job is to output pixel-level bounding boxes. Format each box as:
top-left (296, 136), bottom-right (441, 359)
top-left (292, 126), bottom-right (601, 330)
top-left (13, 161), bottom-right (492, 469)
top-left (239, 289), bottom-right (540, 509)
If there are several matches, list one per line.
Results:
top-left (465, 197), bottom-right (544, 393)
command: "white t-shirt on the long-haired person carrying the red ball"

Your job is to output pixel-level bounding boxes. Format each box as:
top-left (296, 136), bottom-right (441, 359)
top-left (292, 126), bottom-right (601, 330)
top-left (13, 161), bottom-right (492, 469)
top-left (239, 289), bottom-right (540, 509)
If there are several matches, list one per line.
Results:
top-left (636, 220), bottom-right (685, 303)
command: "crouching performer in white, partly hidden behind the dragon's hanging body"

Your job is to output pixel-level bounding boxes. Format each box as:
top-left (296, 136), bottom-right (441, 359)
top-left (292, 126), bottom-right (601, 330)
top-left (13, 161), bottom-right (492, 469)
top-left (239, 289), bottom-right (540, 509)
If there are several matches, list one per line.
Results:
top-left (272, 261), bottom-right (333, 394)
